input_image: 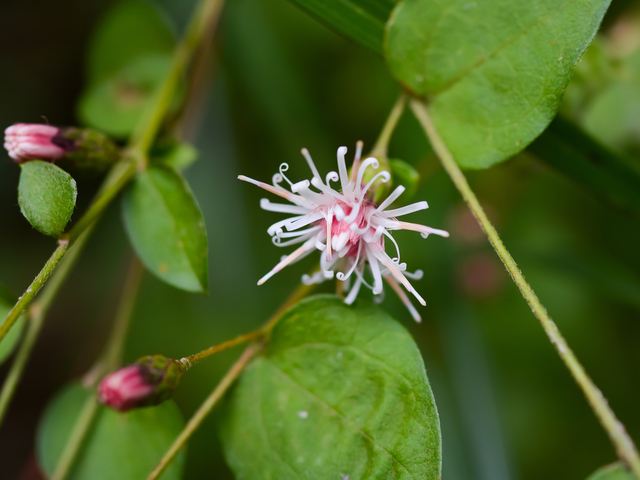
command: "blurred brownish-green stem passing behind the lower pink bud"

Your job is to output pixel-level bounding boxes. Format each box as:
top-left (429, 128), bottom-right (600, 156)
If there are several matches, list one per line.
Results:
top-left (51, 257), bottom-right (144, 480)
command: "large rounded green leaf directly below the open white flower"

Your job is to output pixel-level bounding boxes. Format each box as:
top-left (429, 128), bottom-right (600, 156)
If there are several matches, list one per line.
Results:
top-left (221, 295), bottom-right (441, 480)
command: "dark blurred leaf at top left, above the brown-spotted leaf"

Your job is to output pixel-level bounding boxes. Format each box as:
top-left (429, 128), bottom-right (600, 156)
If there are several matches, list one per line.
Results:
top-left (87, 0), bottom-right (175, 84)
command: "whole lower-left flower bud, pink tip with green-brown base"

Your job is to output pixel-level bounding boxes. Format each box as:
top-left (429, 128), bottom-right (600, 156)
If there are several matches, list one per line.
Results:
top-left (98, 355), bottom-right (185, 412)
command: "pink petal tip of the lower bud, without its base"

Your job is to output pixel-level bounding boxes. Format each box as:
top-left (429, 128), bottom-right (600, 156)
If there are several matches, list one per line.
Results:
top-left (98, 365), bottom-right (156, 412)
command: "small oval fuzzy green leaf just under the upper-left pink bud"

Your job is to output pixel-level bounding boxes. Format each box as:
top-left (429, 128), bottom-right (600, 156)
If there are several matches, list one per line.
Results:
top-left (18, 160), bottom-right (78, 237)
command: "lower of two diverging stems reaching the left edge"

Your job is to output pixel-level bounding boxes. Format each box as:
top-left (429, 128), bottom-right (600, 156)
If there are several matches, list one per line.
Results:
top-left (0, 229), bottom-right (92, 424)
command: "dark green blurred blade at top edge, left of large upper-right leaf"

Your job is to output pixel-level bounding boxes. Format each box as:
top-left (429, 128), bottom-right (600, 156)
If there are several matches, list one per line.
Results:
top-left (284, 0), bottom-right (397, 54)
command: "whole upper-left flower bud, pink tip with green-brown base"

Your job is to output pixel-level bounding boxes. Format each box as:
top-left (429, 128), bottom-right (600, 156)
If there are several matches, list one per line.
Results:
top-left (4, 123), bottom-right (119, 171)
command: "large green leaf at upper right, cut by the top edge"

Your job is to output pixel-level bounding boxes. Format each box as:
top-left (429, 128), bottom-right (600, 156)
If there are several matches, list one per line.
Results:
top-left (385, 0), bottom-right (610, 168)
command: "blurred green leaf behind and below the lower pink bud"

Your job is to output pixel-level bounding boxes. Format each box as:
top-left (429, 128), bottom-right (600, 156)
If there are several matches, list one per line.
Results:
top-left (37, 384), bottom-right (185, 480)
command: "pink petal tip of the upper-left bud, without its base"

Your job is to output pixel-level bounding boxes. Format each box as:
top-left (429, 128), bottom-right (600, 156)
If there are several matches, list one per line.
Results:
top-left (4, 123), bottom-right (75, 163)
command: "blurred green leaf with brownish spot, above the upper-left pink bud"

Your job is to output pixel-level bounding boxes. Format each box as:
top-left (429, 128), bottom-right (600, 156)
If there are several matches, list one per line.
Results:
top-left (78, 54), bottom-right (171, 138)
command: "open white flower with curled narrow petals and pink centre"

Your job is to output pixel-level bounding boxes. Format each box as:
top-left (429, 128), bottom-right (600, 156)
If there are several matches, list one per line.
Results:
top-left (238, 142), bottom-right (449, 322)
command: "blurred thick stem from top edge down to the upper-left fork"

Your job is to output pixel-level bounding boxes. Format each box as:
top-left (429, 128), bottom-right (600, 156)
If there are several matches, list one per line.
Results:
top-left (133, 0), bottom-right (224, 155)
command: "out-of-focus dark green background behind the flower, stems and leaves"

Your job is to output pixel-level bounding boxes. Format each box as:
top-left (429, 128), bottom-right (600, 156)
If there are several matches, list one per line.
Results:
top-left (0, 0), bottom-right (640, 480)
